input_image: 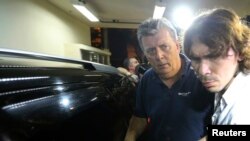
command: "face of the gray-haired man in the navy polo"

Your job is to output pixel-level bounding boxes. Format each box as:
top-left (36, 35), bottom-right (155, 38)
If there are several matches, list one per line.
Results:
top-left (142, 29), bottom-right (180, 79)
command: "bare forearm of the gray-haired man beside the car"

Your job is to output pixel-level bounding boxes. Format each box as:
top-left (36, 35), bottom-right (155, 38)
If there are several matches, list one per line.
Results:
top-left (124, 116), bottom-right (147, 141)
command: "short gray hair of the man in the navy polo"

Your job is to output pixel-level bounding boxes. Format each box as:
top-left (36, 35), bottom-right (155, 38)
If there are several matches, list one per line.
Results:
top-left (137, 18), bottom-right (178, 50)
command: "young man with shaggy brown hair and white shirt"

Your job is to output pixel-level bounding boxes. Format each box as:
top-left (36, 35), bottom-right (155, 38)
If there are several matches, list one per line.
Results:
top-left (184, 8), bottom-right (250, 125)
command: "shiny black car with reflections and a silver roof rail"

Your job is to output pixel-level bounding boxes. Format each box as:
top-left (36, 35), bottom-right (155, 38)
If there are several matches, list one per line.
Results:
top-left (0, 49), bottom-right (135, 141)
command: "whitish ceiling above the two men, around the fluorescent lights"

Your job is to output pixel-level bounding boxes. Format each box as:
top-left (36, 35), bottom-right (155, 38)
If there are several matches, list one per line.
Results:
top-left (48, 0), bottom-right (250, 28)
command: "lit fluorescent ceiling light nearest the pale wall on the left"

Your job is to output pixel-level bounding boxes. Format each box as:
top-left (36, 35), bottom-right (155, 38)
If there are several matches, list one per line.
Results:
top-left (73, 4), bottom-right (99, 22)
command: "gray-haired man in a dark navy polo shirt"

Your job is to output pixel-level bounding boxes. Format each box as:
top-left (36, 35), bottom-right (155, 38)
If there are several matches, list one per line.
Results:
top-left (125, 18), bottom-right (213, 141)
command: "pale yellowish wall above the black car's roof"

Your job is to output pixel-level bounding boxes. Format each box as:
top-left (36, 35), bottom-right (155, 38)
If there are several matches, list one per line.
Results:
top-left (0, 0), bottom-right (91, 56)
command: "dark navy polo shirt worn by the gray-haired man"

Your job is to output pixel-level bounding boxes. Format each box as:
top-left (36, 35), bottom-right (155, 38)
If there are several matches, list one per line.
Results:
top-left (135, 54), bottom-right (214, 141)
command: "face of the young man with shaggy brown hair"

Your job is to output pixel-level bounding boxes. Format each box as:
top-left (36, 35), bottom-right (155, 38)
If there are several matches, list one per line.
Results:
top-left (191, 40), bottom-right (239, 92)
